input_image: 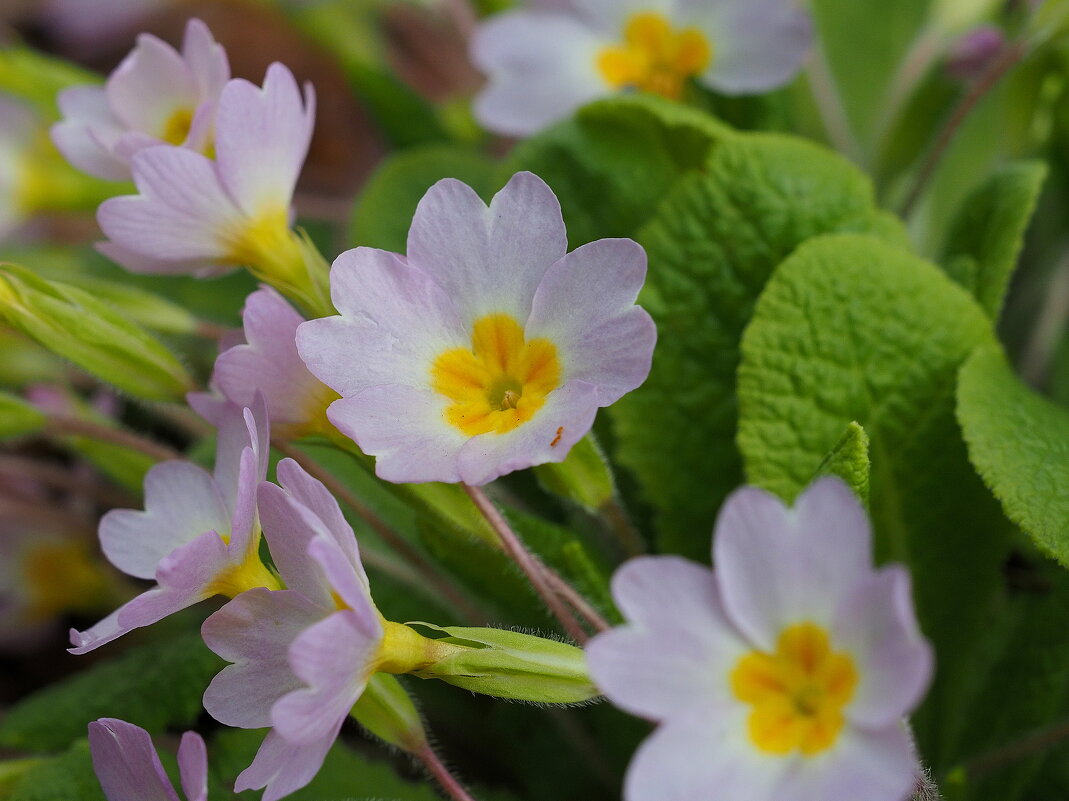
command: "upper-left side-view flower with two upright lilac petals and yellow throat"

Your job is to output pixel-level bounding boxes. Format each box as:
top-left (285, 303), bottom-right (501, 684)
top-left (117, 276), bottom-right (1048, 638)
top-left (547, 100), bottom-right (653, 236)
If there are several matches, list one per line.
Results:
top-left (97, 63), bottom-right (315, 278)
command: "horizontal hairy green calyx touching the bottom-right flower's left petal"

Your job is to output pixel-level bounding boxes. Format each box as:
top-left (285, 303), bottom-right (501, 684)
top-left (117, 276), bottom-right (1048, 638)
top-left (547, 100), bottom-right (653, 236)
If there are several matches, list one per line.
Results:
top-left (409, 622), bottom-right (599, 704)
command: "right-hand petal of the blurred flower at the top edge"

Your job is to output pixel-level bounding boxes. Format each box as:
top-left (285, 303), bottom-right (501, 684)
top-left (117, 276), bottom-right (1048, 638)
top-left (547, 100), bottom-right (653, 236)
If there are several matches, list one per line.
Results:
top-left (680, 0), bottom-right (812, 94)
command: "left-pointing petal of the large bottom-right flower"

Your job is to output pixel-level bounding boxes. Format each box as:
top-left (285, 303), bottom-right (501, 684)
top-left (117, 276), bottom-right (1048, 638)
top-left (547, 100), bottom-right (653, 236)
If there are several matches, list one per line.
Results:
top-left (586, 556), bottom-right (750, 720)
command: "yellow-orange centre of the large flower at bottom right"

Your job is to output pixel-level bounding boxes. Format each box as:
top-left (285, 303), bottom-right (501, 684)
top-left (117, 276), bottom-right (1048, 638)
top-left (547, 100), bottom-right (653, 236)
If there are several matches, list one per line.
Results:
top-left (731, 623), bottom-right (857, 756)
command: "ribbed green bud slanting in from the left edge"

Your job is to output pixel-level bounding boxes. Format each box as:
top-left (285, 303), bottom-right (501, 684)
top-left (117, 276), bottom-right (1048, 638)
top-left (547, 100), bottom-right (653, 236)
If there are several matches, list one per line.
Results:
top-left (0, 262), bottom-right (195, 400)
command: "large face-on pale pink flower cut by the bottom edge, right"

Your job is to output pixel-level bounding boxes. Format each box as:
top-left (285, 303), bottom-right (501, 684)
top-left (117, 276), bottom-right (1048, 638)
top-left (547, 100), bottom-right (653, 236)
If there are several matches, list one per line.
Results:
top-left (587, 478), bottom-right (932, 801)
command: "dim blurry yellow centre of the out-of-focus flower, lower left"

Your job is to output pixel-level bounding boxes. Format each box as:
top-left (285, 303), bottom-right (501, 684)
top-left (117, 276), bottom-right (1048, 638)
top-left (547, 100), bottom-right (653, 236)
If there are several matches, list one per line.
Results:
top-left (22, 541), bottom-right (108, 620)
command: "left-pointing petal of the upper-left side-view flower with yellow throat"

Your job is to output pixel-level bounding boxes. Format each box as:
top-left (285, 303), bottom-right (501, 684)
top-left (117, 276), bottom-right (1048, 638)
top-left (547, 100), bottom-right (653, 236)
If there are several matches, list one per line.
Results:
top-left (96, 147), bottom-right (245, 261)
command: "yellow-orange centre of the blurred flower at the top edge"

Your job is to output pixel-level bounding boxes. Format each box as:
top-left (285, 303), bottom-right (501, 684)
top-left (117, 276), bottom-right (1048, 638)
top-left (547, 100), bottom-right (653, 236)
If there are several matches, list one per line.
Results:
top-left (598, 12), bottom-right (713, 99)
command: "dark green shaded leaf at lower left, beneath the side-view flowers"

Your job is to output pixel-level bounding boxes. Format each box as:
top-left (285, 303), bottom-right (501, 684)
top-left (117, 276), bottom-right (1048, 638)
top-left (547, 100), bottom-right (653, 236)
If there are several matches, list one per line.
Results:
top-left (0, 632), bottom-right (224, 751)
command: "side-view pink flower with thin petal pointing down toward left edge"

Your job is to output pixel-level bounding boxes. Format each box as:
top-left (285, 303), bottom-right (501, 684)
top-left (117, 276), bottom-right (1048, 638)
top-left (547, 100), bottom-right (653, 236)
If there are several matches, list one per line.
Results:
top-left (69, 398), bottom-right (278, 653)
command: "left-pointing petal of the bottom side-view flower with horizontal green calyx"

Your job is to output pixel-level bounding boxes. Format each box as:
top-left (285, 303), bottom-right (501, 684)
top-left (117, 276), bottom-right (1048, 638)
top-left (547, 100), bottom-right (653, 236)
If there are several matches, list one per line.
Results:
top-left (201, 588), bottom-right (318, 728)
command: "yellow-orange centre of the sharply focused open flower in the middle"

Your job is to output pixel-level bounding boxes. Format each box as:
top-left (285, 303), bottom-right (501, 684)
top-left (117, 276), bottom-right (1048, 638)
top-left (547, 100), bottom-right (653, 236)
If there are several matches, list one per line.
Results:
top-left (431, 314), bottom-right (560, 436)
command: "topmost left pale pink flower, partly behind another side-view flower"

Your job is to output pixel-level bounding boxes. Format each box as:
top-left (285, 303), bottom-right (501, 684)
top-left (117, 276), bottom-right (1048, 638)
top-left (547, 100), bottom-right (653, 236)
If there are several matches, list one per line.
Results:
top-left (52, 17), bottom-right (230, 181)
